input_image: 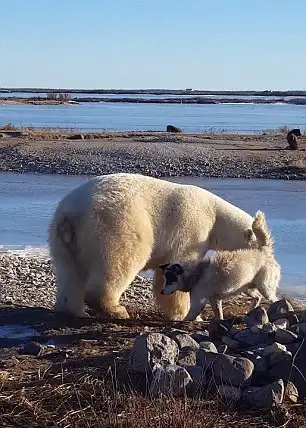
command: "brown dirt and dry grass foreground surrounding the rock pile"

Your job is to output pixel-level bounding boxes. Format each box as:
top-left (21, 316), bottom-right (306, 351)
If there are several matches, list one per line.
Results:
top-left (0, 298), bottom-right (306, 428)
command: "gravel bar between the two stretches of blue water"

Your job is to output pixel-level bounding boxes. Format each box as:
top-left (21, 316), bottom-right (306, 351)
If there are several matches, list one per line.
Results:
top-left (0, 130), bottom-right (306, 180)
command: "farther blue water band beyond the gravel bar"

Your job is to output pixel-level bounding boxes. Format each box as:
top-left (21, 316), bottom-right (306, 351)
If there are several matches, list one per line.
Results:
top-left (0, 100), bottom-right (306, 132)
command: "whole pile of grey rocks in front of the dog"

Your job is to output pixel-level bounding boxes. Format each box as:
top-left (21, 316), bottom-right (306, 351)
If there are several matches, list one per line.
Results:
top-left (129, 299), bottom-right (306, 409)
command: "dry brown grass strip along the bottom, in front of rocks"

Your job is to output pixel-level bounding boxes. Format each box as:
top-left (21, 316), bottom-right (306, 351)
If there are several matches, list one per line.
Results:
top-left (0, 367), bottom-right (306, 428)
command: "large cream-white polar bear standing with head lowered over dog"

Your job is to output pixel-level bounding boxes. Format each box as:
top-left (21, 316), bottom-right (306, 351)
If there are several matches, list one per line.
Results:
top-left (49, 173), bottom-right (256, 320)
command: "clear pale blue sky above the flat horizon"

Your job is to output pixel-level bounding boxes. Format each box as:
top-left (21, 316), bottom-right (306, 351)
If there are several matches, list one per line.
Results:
top-left (0, 0), bottom-right (306, 90)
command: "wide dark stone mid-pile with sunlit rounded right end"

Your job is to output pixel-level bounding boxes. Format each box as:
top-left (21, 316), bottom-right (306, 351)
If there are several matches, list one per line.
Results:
top-left (197, 350), bottom-right (254, 387)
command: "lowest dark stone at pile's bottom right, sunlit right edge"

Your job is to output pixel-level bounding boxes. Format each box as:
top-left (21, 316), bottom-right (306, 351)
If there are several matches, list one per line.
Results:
top-left (242, 379), bottom-right (285, 410)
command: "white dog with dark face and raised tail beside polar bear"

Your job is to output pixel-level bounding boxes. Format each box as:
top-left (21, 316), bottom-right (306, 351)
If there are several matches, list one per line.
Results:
top-left (162, 211), bottom-right (281, 320)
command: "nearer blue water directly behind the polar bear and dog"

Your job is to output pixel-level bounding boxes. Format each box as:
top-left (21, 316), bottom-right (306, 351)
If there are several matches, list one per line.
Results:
top-left (0, 173), bottom-right (306, 297)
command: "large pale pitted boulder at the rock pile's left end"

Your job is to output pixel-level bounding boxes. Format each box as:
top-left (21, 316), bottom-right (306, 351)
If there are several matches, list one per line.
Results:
top-left (129, 333), bottom-right (179, 373)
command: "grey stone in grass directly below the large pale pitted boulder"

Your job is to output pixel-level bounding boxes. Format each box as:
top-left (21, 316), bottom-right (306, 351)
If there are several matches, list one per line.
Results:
top-left (149, 364), bottom-right (192, 397)
